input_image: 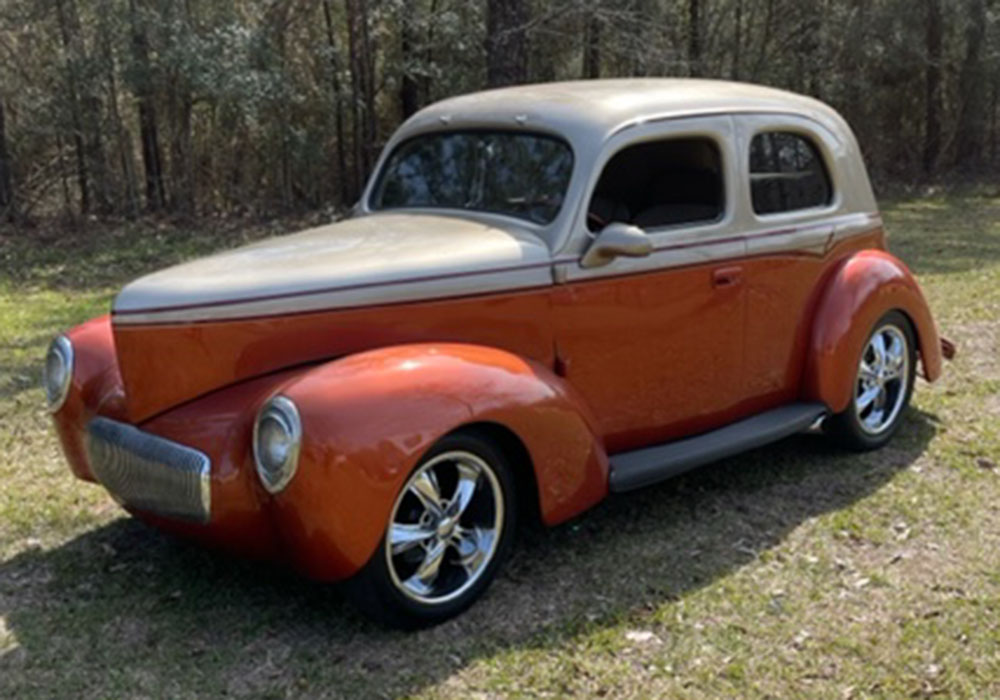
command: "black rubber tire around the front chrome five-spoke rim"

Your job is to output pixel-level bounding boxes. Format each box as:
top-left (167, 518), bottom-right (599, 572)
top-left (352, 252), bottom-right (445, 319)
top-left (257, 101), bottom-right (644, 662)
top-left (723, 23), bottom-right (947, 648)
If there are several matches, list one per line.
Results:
top-left (344, 430), bottom-right (518, 629)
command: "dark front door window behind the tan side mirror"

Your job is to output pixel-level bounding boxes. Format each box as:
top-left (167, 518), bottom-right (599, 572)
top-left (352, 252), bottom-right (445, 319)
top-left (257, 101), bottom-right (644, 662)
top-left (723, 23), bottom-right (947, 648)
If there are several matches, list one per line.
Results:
top-left (587, 137), bottom-right (724, 231)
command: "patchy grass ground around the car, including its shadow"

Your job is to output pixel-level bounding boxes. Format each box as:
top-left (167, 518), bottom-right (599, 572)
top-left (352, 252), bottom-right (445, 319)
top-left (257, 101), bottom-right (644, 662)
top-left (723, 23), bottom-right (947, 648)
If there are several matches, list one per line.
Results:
top-left (0, 197), bottom-right (1000, 699)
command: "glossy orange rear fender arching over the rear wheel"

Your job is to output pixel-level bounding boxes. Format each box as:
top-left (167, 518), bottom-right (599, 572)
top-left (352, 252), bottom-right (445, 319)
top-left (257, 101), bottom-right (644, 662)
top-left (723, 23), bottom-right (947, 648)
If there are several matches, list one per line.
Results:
top-left (803, 250), bottom-right (941, 413)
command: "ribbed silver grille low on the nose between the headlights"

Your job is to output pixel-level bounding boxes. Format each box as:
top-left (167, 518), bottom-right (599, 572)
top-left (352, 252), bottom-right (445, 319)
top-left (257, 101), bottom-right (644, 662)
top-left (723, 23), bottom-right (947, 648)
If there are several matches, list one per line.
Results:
top-left (87, 418), bottom-right (211, 523)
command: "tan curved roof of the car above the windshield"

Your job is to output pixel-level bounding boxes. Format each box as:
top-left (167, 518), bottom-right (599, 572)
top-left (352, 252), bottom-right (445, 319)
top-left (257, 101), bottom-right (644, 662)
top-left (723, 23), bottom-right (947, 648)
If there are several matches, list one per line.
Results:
top-left (400, 78), bottom-right (847, 140)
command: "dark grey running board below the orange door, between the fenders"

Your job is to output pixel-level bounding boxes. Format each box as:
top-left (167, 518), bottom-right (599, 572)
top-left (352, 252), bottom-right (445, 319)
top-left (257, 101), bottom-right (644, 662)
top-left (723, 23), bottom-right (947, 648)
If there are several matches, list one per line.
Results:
top-left (609, 403), bottom-right (827, 492)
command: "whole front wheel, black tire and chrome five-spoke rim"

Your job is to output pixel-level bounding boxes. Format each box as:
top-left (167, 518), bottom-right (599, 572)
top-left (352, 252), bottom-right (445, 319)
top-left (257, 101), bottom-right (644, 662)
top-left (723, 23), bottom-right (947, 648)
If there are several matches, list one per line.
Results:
top-left (347, 431), bottom-right (517, 628)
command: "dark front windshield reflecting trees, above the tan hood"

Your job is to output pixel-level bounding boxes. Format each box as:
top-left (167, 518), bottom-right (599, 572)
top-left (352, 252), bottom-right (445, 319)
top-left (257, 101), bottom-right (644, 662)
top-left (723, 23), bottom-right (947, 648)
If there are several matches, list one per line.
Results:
top-left (369, 131), bottom-right (573, 224)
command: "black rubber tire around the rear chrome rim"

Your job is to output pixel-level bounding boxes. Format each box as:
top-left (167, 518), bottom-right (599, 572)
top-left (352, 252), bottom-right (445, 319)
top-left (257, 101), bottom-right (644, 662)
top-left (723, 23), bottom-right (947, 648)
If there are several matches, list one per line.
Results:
top-left (824, 311), bottom-right (917, 452)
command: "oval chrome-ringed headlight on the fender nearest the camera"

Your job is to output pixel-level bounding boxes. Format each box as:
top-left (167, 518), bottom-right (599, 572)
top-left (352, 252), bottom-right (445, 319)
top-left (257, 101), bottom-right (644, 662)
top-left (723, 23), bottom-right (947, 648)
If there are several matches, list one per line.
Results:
top-left (253, 396), bottom-right (302, 493)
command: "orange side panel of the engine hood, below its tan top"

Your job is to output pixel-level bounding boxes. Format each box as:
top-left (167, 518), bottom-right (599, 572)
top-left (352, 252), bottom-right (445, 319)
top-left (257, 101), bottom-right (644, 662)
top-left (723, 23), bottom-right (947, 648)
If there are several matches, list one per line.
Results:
top-left (114, 290), bottom-right (552, 422)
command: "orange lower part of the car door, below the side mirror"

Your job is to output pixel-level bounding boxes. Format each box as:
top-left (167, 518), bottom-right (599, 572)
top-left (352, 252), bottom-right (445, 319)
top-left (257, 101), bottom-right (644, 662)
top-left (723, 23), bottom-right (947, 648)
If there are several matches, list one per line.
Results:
top-left (552, 254), bottom-right (745, 452)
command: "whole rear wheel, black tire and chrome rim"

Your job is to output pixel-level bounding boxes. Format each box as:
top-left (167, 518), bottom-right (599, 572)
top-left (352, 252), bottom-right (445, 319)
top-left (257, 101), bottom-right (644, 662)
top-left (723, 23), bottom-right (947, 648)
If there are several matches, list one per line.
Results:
top-left (827, 311), bottom-right (916, 451)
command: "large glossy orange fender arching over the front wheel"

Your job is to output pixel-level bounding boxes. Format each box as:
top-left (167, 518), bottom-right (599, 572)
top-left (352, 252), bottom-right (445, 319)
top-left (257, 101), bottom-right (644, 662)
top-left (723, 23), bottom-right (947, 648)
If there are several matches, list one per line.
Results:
top-left (273, 344), bottom-right (608, 579)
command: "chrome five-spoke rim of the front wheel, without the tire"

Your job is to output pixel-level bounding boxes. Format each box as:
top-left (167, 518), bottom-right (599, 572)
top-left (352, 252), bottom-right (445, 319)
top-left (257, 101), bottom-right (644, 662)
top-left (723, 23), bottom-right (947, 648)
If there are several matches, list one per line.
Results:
top-left (385, 450), bottom-right (504, 604)
